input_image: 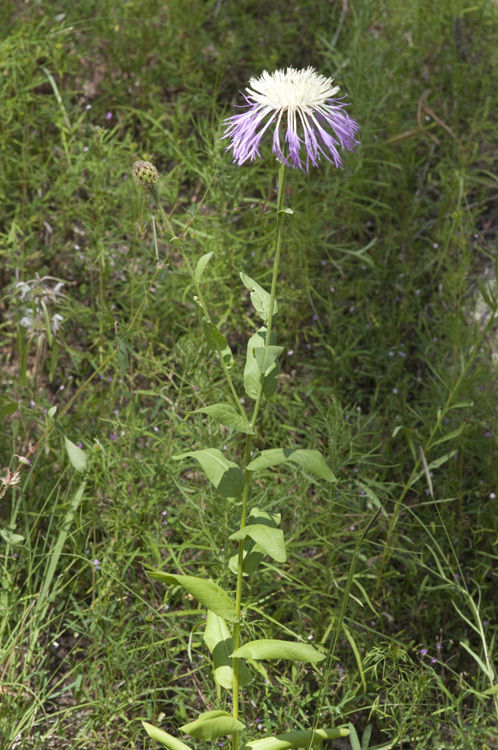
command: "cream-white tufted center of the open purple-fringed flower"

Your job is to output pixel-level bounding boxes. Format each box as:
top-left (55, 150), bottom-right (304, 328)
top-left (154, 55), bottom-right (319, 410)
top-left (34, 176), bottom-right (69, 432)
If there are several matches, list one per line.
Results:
top-left (246, 66), bottom-right (339, 111)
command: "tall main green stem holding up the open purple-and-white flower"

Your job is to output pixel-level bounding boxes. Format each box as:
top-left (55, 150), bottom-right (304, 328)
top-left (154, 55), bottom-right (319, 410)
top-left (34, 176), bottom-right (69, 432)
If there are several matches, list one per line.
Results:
top-left (232, 164), bottom-right (286, 750)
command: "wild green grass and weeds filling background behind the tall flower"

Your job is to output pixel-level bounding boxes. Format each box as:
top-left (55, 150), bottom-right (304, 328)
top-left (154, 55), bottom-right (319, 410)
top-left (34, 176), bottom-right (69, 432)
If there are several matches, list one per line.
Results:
top-left (0, 0), bottom-right (498, 750)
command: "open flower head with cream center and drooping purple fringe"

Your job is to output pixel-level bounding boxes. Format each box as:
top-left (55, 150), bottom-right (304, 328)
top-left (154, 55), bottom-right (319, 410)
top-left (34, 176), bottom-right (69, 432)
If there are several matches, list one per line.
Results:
top-left (223, 67), bottom-right (358, 171)
